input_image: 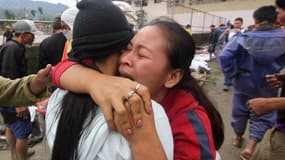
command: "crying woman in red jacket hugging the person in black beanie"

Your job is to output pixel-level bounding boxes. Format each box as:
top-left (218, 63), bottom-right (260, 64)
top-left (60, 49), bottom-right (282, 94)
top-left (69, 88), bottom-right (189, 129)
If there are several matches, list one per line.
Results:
top-left (54, 18), bottom-right (224, 160)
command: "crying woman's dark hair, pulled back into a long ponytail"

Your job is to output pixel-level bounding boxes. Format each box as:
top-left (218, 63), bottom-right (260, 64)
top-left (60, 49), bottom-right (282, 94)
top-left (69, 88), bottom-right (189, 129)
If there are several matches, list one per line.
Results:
top-left (148, 17), bottom-right (224, 149)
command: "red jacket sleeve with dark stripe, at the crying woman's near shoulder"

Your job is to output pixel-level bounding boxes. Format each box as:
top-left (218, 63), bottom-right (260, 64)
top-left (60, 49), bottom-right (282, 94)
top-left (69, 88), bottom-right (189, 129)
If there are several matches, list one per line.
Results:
top-left (171, 107), bottom-right (216, 160)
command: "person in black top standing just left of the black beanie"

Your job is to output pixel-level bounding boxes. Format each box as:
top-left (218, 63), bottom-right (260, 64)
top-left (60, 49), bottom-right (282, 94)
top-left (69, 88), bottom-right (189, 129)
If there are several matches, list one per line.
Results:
top-left (38, 17), bottom-right (66, 70)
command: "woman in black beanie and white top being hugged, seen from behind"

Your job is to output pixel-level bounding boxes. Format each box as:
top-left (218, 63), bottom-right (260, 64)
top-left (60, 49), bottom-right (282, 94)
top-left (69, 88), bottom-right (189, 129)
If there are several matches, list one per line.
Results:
top-left (46, 0), bottom-right (173, 160)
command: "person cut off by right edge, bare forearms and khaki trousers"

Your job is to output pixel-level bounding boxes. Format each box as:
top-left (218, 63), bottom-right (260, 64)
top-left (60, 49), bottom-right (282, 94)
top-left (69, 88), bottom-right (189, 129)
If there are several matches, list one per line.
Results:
top-left (247, 0), bottom-right (285, 160)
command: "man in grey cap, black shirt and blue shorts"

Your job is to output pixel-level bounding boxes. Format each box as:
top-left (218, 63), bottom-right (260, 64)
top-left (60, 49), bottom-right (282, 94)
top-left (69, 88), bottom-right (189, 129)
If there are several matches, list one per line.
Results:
top-left (0, 20), bottom-right (36, 160)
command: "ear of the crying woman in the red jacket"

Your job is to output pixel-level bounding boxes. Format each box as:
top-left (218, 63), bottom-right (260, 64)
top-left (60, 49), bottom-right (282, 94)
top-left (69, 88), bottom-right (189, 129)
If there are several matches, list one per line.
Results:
top-left (164, 69), bottom-right (184, 88)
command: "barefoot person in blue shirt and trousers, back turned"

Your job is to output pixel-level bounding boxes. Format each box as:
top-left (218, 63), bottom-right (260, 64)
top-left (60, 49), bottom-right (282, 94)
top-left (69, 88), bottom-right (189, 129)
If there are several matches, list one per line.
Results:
top-left (220, 6), bottom-right (285, 159)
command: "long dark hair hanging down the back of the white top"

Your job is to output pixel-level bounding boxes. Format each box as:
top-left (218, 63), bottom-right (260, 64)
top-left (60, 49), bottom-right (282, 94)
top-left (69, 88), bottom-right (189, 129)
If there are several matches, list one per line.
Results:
top-left (52, 64), bottom-right (98, 160)
